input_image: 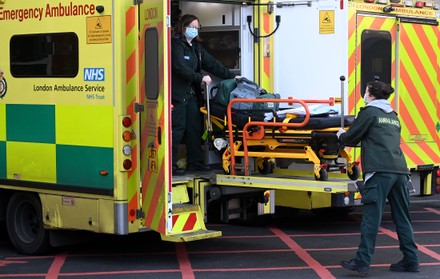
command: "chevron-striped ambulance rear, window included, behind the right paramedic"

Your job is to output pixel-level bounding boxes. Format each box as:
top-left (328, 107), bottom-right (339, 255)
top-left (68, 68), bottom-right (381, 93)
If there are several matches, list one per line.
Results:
top-left (349, 13), bottom-right (440, 194)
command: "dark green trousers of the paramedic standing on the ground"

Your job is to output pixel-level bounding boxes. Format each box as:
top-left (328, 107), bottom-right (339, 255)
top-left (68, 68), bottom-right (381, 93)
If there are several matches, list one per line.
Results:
top-left (355, 172), bottom-right (419, 267)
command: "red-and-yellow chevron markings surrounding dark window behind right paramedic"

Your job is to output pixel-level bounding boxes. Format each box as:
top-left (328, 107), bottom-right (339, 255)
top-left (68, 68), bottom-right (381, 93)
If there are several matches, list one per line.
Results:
top-left (348, 8), bottom-right (440, 168)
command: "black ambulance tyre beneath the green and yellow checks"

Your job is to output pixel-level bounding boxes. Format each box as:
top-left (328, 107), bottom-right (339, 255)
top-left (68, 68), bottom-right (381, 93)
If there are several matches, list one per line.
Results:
top-left (6, 193), bottom-right (50, 255)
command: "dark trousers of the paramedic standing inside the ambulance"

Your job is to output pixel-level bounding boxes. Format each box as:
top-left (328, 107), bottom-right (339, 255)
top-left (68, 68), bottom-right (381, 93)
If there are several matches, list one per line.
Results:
top-left (171, 97), bottom-right (204, 166)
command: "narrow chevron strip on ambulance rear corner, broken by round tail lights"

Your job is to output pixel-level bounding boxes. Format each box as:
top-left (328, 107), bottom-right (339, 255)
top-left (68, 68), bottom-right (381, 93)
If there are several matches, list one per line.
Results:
top-left (125, 6), bottom-right (139, 222)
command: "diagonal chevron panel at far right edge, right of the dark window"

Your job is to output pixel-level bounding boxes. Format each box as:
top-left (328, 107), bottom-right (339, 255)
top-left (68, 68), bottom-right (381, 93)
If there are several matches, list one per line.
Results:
top-left (398, 23), bottom-right (440, 167)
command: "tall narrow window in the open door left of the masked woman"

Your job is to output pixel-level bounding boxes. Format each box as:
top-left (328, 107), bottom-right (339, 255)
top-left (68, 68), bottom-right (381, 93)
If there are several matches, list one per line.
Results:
top-left (144, 28), bottom-right (159, 100)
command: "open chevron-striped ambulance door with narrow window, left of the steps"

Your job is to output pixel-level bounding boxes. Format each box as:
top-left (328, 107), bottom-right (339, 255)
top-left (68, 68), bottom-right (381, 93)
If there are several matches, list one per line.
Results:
top-left (138, 0), bottom-right (172, 237)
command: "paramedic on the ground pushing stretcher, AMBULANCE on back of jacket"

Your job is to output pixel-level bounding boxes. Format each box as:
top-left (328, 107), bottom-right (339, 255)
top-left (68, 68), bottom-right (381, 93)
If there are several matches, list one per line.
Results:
top-left (337, 81), bottom-right (419, 276)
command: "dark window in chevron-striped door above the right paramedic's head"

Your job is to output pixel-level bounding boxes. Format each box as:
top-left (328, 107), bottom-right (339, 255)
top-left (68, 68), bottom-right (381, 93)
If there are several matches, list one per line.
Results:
top-left (361, 30), bottom-right (392, 94)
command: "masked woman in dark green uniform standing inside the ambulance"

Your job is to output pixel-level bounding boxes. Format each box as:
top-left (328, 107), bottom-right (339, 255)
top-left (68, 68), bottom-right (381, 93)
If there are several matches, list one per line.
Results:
top-left (171, 14), bottom-right (236, 175)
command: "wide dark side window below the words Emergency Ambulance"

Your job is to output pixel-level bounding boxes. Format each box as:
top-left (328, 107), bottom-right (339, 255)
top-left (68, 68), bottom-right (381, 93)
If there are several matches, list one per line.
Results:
top-left (10, 33), bottom-right (79, 77)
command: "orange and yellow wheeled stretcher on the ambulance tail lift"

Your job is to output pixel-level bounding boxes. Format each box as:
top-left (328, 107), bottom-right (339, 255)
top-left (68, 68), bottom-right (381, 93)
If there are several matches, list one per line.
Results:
top-left (201, 98), bottom-right (360, 180)
